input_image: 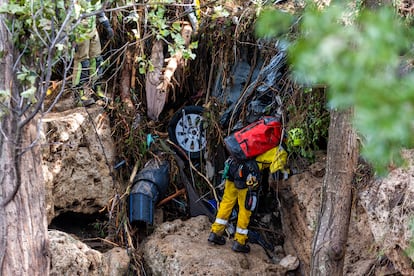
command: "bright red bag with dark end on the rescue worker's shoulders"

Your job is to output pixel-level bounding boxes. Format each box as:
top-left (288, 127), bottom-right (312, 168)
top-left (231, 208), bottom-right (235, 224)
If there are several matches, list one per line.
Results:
top-left (224, 116), bottom-right (282, 160)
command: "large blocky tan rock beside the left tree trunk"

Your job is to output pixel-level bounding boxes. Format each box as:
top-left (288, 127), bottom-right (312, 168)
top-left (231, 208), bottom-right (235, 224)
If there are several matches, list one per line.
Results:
top-left (41, 107), bottom-right (117, 223)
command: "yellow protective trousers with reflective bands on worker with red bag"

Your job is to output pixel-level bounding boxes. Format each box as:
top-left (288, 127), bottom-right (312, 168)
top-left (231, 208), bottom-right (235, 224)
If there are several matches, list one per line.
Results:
top-left (211, 179), bottom-right (252, 245)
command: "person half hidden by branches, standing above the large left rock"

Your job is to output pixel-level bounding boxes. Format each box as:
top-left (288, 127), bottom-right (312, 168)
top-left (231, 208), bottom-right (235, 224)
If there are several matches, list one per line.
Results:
top-left (72, 0), bottom-right (114, 106)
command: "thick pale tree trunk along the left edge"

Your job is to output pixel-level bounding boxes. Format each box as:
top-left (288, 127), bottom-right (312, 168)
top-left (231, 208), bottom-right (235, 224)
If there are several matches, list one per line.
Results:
top-left (0, 6), bottom-right (49, 276)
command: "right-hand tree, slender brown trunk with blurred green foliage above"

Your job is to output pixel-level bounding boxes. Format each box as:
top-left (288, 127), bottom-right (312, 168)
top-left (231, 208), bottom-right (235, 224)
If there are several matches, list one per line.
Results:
top-left (259, 1), bottom-right (414, 275)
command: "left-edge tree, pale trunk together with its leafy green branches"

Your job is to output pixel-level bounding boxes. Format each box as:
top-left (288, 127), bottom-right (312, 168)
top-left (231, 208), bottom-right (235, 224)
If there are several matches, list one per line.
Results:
top-left (0, 0), bottom-right (90, 275)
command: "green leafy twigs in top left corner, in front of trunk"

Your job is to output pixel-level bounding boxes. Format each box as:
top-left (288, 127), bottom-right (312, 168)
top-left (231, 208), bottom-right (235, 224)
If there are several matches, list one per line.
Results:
top-left (0, 0), bottom-right (73, 114)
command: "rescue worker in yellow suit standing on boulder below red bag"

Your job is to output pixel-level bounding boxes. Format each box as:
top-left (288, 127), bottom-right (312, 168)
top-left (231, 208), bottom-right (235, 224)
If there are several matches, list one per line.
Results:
top-left (208, 146), bottom-right (287, 253)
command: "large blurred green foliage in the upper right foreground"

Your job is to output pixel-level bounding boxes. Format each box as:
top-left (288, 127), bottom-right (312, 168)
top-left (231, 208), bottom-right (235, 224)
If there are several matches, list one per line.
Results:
top-left (256, 3), bottom-right (414, 174)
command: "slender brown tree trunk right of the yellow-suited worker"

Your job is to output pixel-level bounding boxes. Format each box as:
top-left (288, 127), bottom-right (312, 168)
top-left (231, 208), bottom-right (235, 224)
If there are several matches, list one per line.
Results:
top-left (311, 109), bottom-right (358, 275)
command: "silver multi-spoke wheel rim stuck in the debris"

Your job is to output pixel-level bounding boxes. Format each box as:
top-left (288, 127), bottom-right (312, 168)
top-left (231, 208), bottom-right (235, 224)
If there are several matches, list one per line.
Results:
top-left (175, 113), bottom-right (206, 152)
